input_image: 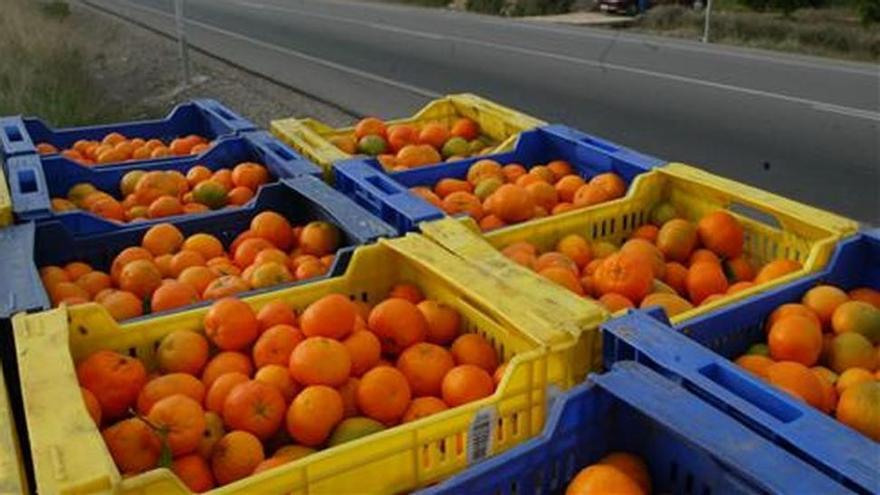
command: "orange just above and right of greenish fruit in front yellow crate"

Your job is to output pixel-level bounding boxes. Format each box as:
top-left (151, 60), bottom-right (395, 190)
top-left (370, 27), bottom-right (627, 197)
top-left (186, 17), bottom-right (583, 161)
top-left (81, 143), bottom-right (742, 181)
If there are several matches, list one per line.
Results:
top-left (357, 366), bottom-right (412, 424)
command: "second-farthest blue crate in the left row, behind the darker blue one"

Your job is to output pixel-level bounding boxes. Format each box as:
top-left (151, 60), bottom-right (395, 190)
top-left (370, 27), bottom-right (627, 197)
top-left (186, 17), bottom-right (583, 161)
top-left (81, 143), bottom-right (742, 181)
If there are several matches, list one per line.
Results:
top-left (6, 131), bottom-right (321, 230)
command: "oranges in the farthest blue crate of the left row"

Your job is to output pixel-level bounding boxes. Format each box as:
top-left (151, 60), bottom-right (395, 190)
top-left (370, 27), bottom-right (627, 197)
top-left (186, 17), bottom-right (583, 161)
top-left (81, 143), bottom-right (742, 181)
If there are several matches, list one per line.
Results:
top-left (37, 132), bottom-right (211, 167)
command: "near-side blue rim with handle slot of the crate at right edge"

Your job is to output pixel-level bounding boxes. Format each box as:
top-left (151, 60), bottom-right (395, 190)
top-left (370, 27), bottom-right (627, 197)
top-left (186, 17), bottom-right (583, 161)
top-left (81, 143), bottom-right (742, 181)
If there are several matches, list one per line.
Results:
top-left (602, 308), bottom-right (880, 494)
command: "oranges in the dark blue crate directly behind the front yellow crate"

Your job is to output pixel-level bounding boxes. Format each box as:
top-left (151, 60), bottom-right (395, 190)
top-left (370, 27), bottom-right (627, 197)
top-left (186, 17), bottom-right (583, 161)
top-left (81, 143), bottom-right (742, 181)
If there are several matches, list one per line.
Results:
top-left (40, 216), bottom-right (340, 321)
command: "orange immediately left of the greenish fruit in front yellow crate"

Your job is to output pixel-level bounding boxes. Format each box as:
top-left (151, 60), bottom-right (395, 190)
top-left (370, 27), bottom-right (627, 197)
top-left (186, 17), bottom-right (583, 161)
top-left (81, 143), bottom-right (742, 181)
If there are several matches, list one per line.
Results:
top-left (286, 385), bottom-right (344, 447)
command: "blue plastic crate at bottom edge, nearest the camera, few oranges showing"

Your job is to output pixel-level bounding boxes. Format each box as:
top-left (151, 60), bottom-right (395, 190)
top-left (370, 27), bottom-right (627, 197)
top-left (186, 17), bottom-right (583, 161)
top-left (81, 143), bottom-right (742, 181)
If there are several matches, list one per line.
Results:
top-left (419, 362), bottom-right (850, 495)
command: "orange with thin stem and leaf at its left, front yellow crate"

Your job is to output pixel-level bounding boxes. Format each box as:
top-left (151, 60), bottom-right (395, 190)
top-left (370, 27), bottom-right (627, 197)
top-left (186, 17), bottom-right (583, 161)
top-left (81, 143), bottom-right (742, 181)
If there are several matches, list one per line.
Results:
top-left (147, 394), bottom-right (205, 456)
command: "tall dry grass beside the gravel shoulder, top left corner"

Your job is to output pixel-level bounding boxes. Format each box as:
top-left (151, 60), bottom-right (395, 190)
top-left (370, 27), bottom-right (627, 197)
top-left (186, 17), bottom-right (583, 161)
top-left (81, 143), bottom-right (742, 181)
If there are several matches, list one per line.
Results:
top-left (0, 0), bottom-right (134, 126)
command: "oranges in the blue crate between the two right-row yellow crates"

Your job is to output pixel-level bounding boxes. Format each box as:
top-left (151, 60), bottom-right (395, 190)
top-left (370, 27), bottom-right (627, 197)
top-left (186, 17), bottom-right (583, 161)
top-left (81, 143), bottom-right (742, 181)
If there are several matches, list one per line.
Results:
top-left (411, 159), bottom-right (626, 231)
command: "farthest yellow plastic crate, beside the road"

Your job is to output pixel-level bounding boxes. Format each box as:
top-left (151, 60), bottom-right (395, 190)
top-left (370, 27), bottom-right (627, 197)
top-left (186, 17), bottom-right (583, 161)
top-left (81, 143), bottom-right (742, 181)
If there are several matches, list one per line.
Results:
top-left (270, 93), bottom-right (546, 181)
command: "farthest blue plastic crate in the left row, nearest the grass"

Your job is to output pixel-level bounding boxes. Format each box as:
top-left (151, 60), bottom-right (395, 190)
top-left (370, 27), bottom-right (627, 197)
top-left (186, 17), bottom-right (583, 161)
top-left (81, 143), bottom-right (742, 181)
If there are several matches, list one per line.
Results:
top-left (0, 99), bottom-right (257, 158)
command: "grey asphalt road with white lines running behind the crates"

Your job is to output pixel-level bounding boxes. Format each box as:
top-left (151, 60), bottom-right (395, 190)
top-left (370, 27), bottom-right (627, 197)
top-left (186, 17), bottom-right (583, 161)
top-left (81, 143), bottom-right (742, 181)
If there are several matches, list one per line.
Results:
top-left (89, 0), bottom-right (880, 224)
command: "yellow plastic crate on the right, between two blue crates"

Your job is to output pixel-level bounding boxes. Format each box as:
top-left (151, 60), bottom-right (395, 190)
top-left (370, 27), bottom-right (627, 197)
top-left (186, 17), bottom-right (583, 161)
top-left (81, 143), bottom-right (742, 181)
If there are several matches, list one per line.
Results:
top-left (420, 163), bottom-right (858, 330)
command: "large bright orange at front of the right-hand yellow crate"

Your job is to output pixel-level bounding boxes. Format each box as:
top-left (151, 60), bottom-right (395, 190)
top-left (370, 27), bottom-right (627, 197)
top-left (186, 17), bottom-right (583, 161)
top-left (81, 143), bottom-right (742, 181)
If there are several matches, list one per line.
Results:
top-left (593, 253), bottom-right (654, 303)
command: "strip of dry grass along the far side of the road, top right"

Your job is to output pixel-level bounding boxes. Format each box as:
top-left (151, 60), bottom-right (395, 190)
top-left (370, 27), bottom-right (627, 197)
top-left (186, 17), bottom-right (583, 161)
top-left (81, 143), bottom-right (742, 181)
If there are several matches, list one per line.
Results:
top-left (634, 6), bottom-right (880, 62)
